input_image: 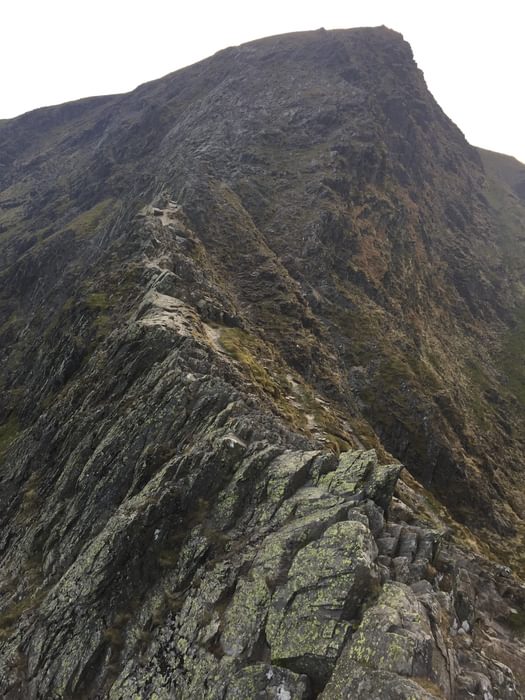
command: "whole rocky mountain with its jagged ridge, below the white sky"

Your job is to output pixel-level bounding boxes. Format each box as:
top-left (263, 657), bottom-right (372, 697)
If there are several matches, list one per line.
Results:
top-left (0, 28), bottom-right (525, 700)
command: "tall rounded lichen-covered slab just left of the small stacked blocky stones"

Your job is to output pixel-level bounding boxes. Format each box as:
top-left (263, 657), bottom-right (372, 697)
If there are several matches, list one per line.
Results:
top-left (266, 521), bottom-right (377, 684)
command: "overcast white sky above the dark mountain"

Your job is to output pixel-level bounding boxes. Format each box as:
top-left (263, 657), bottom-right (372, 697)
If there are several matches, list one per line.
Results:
top-left (0, 0), bottom-right (525, 162)
